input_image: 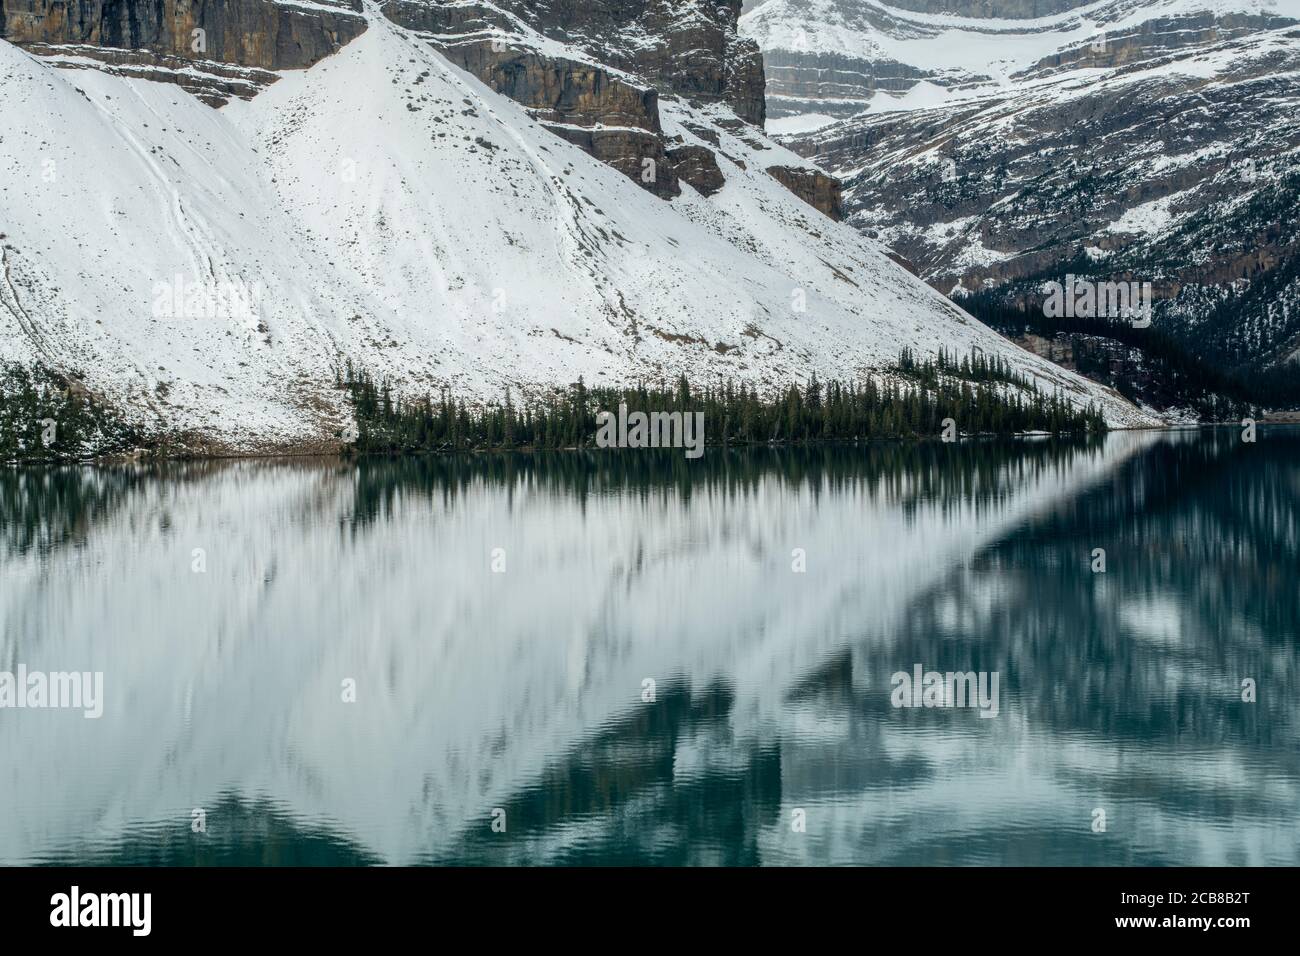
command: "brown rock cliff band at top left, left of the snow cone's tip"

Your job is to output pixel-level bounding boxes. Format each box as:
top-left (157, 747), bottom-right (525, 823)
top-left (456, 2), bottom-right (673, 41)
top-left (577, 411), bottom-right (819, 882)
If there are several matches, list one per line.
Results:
top-left (0, 0), bottom-right (365, 105)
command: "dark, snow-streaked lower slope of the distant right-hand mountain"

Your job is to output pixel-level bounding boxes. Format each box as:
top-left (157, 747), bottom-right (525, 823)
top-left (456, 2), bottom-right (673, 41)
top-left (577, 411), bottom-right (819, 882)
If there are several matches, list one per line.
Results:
top-left (790, 19), bottom-right (1300, 368)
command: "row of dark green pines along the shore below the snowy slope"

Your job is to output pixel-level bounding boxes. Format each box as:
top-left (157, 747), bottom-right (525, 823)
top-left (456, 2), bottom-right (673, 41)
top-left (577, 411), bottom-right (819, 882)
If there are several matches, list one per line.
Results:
top-left (337, 350), bottom-right (1105, 454)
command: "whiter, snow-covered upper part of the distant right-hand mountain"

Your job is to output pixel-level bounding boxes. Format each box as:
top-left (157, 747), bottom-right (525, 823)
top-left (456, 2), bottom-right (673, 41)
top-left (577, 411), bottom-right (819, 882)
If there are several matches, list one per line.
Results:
top-left (741, 0), bottom-right (1300, 118)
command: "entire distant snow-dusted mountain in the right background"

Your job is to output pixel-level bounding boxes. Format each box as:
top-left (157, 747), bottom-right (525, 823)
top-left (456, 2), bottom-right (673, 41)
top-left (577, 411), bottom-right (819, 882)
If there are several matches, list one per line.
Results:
top-left (742, 0), bottom-right (1300, 369)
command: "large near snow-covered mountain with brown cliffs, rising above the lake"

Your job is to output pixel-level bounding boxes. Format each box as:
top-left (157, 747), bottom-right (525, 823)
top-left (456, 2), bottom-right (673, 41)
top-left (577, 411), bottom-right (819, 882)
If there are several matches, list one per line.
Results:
top-left (0, 0), bottom-right (1149, 446)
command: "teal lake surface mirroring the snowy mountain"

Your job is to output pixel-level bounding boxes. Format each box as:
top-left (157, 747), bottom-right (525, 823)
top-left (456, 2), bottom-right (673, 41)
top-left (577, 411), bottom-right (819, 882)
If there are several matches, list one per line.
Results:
top-left (0, 428), bottom-right (1300, 865)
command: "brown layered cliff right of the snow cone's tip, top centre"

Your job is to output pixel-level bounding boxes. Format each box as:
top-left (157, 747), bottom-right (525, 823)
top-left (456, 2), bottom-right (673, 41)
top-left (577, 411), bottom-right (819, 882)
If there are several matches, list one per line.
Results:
top-left (384, 0), bottom-right (837, 215)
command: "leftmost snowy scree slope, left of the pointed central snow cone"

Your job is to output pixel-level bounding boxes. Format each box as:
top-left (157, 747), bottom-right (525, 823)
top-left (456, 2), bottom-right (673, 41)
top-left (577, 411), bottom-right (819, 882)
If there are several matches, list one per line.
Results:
top-left (0, 43), bottom-right (353, 447)
